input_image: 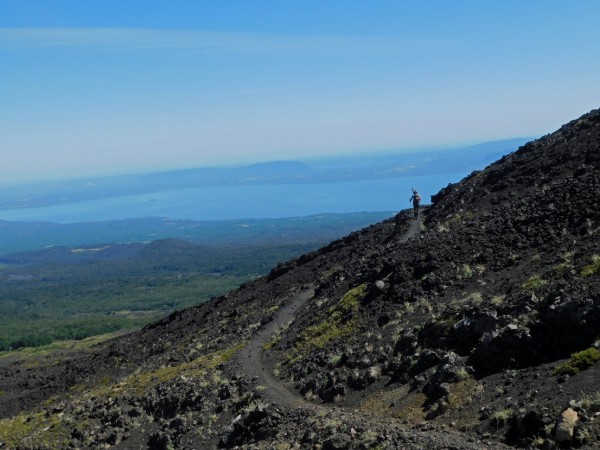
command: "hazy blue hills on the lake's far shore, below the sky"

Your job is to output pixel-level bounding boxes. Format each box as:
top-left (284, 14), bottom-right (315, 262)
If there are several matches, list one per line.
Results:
top-left (0, 138), bottom-right (528, 212)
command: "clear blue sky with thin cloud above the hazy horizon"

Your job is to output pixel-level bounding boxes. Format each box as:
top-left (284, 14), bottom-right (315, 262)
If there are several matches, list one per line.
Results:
top-left (0, 0), bottom-right (600, 183)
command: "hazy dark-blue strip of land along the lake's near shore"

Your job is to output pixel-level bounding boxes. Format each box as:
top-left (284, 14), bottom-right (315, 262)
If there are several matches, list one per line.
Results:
top-left (0, 212), bottom-right (393, 255)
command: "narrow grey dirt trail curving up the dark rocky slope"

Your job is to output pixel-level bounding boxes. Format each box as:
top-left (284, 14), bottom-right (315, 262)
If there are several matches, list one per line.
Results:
top-left (236, 214), bottom-right (423, 410)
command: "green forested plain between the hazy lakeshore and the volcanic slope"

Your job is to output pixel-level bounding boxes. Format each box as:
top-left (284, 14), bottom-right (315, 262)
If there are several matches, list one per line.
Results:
top-left (0, 214), bottom-right (390, 352)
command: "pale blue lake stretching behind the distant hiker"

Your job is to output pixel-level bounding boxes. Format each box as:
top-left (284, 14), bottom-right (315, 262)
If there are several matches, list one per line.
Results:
top-left (0, 173), bottom-right (467, 223)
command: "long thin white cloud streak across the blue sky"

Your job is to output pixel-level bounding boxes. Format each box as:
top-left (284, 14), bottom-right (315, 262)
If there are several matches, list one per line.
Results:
top-left (0, 28), bottom-right (459, 55)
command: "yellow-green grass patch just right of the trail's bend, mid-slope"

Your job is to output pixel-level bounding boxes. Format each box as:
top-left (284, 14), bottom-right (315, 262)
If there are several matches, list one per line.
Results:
top-left (287, 284), bottom-right (367, 363)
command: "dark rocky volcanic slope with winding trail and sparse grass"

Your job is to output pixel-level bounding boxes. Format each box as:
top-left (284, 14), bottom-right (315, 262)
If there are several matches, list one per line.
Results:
top-left (0, 110), bottom-right (600, 449)
